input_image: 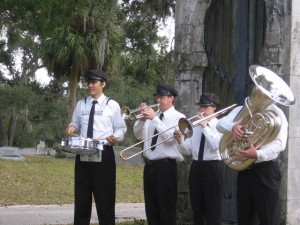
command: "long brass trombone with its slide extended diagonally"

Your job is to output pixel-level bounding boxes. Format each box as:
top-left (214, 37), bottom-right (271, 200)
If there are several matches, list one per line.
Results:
top-left (120, 104), bottom-right (237, 160)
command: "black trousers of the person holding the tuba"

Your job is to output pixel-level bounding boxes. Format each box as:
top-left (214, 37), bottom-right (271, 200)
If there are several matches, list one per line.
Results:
top-left (237, 160), bottom-right (281, 225)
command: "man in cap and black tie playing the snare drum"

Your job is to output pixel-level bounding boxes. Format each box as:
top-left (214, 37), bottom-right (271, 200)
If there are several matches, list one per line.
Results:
top-left (65, 70), bottom-right (127, 225)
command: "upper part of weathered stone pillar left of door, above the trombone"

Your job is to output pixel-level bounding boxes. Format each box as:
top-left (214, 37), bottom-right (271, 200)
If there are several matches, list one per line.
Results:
top-left (174, 0), bottom-right (210, 117)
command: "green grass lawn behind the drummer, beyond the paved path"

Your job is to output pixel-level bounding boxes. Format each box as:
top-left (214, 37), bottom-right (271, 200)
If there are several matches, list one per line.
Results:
top-left (0, 156), bottom-right (144, 206)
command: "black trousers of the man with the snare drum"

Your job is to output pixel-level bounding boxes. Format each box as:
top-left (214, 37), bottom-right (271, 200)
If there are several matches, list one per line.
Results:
top-left (74, 146), bottom-right (116, 225)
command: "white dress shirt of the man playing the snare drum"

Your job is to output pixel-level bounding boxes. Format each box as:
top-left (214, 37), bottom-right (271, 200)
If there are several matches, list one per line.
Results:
top-left (70, 94), bottom-right (127, 141)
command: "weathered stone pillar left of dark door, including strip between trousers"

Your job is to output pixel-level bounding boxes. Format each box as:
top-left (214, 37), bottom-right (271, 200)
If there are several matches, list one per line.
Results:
top-left (175, 0), bottom-right (210, 225)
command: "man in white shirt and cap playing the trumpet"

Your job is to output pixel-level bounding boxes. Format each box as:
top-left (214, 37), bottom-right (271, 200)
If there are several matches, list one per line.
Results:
top-left (133, 85), bottom-right (185, 225)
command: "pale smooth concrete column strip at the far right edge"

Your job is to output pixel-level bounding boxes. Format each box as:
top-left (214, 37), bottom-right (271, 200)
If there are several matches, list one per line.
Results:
top-left (284, 0), bottom-right (300, 225)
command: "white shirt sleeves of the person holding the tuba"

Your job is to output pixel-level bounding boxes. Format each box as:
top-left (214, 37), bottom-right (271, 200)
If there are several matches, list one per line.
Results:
top-left (217, 104), bottom-right (288, 163)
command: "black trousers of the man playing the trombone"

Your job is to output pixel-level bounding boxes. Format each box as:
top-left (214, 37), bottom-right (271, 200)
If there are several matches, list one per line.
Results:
top-left (189, 160), bottom-right (223, 225)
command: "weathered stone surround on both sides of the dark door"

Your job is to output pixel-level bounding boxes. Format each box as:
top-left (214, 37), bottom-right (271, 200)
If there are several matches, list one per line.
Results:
top-left (175, 0), bottom-right (300, 225)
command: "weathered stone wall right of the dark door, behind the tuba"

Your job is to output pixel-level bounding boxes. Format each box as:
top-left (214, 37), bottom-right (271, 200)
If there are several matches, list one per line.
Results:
top-left (260, 0), bottom-right (300, 225)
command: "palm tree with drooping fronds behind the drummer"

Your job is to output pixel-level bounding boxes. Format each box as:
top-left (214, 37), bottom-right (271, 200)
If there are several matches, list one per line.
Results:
top-left (42, 0), bottom-right (117, 113)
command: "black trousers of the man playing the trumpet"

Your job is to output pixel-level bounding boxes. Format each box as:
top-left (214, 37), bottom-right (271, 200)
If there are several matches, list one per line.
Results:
top-left (144, 159), bottom-right (178, 225)
